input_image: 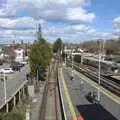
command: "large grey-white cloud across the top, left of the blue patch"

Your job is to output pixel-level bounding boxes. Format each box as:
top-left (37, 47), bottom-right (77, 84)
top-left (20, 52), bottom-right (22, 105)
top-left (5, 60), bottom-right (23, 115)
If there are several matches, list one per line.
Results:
top-left (0, 0), bottom-right (95, 24)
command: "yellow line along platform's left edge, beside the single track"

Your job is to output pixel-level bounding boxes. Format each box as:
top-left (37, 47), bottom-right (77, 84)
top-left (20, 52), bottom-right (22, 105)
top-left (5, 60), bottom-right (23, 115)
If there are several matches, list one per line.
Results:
top-left (60, 69), bottom-right (77, 120)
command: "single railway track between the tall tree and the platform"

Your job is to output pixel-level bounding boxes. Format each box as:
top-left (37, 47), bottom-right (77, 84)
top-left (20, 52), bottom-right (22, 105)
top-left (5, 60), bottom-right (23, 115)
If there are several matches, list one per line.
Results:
top-left (39, 61), bottom-right (58, 120)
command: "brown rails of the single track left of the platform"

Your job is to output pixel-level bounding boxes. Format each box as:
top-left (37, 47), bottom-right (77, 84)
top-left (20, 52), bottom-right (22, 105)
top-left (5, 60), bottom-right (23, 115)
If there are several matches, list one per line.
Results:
top-left (39, 61), bottom-right (58, 120)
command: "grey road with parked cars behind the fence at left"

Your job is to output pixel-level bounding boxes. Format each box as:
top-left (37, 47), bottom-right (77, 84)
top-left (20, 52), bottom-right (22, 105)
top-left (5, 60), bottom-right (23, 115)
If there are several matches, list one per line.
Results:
top-left (0, 65), bottom-right (29, 109)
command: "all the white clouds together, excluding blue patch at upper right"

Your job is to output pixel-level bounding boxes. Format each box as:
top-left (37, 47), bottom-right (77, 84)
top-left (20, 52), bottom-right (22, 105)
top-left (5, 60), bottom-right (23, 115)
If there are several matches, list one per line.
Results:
top-left (0, 0), bottom-right (120, 42)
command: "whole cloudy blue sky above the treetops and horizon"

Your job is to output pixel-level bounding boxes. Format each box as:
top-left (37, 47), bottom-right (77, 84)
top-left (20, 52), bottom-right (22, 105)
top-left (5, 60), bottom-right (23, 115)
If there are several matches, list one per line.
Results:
top-left (0, 0), bottom-right (120, 44)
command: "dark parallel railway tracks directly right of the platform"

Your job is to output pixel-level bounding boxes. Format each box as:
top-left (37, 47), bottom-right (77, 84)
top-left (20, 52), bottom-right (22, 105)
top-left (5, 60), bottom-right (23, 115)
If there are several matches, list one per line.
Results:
top-left (67, 62), bottom-right (120, 97)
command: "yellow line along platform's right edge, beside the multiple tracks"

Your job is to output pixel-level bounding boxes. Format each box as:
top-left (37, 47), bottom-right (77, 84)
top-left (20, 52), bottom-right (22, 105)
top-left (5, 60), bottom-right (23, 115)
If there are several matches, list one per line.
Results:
top-left (74, 71), bottom-right (120, 104)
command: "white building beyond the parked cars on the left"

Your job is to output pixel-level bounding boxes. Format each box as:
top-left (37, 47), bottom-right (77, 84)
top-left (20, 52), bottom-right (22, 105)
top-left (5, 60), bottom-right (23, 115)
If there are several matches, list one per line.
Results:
top-left (14, 49), bottom-right (25, 62)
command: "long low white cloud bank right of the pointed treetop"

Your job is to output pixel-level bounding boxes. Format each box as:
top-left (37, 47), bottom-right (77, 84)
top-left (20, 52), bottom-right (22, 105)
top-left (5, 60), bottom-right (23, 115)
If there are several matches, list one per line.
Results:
top-left (44, 24), bottom-right (116, 43)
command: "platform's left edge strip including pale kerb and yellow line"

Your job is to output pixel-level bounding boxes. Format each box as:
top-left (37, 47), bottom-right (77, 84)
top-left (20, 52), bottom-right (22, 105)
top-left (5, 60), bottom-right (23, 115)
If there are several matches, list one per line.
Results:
top-left (58, 68), bottom-right (84, 120)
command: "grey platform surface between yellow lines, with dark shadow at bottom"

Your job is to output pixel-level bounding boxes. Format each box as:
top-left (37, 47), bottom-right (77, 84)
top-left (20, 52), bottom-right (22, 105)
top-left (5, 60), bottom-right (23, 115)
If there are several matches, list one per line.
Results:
top-left (63, 68), bottom-right (120, 120)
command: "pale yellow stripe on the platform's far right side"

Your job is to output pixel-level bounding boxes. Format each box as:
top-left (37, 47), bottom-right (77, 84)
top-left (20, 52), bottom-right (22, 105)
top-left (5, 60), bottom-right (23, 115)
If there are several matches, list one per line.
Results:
top-left (74, 71), bottom-right (120, 104)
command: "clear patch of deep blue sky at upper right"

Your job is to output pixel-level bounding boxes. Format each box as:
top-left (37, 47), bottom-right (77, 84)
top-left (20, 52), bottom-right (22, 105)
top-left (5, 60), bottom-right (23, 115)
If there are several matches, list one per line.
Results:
top-left (89, 0), bottom-right (120, 31)
